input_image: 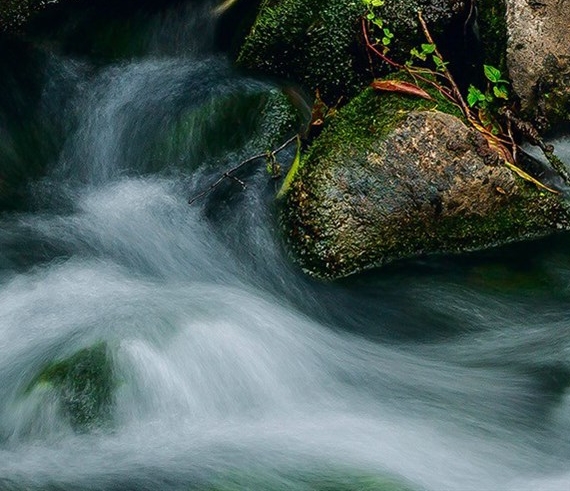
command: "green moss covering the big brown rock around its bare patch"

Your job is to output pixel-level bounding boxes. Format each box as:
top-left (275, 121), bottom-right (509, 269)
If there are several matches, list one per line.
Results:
top-left (282, 79), bottom-right (569, 278)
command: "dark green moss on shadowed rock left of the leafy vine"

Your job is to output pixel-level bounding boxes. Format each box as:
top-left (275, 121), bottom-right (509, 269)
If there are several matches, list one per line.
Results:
top-left (238, 0), bottom-right (367, 104)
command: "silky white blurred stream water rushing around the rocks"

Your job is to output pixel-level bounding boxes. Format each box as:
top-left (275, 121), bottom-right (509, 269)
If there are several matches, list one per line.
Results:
top-left (0, 4), bottom-right (570, 491)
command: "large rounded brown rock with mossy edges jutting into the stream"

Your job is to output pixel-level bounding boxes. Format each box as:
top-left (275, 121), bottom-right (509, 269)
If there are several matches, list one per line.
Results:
top-left (282, 90), bottom-right (569, 278)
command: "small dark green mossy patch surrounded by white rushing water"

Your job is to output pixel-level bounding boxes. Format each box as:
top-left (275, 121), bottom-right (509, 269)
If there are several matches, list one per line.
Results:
top-left (26, 342), bottom-right (116, 431)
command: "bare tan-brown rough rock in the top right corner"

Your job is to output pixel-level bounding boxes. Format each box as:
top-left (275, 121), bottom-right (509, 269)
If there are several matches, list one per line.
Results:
top-left (507, 0), bottom-right (570, 129)
